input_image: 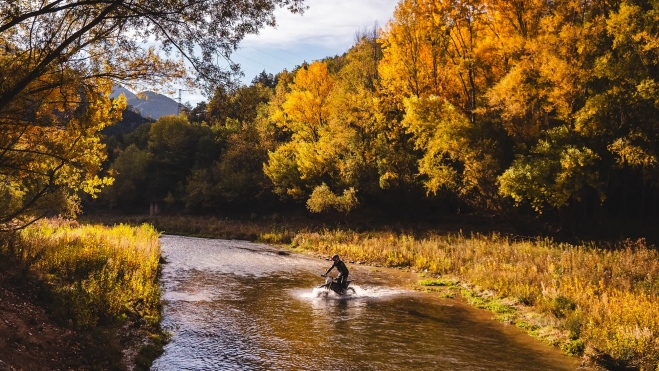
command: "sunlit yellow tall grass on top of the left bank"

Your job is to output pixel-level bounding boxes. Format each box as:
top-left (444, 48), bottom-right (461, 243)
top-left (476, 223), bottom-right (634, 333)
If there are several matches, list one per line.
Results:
top-left (1, 221), bottom-right (160, 327)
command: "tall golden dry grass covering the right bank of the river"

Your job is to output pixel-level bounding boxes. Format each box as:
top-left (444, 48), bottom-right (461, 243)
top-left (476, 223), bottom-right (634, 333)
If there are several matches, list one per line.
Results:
top-left (292, 231), bottom-right (659, 370)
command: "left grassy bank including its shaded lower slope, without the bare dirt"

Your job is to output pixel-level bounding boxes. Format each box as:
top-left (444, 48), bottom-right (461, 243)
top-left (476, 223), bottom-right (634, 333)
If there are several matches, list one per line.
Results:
top-left (0, 221), bottom-right (162, 369)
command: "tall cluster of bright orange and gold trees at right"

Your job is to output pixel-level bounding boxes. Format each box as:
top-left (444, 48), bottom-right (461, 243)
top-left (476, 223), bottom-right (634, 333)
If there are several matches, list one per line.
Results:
top-left (379, 0), bottom-right (659, 218)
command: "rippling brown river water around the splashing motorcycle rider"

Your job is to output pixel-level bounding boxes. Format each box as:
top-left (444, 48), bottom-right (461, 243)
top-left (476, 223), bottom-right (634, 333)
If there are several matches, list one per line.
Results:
top-left (152, 236), bottom-right (579, 370)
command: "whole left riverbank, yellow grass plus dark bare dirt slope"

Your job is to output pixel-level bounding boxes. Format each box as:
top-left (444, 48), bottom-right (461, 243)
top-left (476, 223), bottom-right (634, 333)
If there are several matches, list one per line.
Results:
top-left (0, 221), bottom-right (164, 370)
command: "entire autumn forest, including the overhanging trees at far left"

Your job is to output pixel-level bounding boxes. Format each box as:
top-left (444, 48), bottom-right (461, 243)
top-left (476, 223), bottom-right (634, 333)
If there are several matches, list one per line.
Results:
top-left (0, 0), bottom-right (659, 235)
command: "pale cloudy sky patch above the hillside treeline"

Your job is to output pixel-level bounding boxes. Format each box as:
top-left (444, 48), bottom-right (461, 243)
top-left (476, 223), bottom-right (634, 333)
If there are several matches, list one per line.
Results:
top-left (182, 0), bottom-right (398, 106)
